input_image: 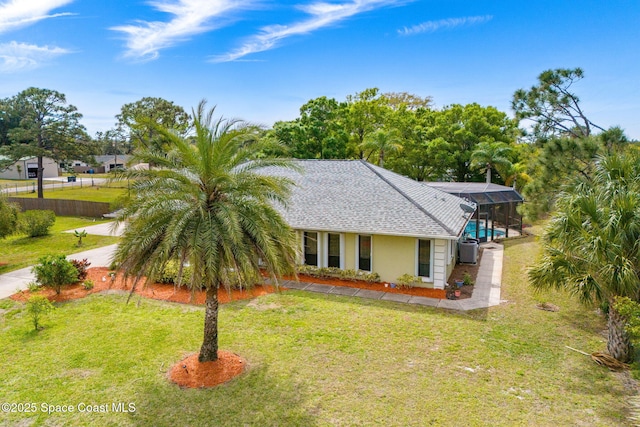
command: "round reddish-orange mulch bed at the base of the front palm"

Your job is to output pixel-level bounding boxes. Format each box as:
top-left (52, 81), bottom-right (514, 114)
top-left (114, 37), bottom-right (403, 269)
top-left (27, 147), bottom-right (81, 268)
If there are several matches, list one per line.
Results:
top-left (168, 350), bottom-right (246, 388)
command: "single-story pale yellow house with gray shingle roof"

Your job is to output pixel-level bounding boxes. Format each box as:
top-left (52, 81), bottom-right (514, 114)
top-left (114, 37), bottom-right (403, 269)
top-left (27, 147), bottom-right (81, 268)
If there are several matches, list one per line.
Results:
top-left (265, 160), bottom-right (475, 289)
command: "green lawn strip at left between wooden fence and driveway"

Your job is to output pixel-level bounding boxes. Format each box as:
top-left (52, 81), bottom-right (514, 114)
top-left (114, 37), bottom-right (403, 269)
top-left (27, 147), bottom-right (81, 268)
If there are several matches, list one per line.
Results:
top-left (0, 216), bottom-right (118, 274)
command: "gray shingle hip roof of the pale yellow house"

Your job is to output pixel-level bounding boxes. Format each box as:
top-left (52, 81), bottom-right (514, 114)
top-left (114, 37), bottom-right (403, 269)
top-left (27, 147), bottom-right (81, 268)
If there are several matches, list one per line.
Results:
top-left (265, 160), bottom-right (475, 238)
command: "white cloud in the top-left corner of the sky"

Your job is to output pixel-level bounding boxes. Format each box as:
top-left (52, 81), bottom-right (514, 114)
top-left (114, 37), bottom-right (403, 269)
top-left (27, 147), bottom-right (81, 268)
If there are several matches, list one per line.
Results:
top-left (0, 0), bottom-right (73, 34)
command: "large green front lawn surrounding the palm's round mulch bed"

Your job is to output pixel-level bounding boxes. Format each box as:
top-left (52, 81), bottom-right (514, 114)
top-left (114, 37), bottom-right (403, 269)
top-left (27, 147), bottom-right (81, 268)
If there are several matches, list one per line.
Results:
top-left (0, 238), bottom-right (627, 426)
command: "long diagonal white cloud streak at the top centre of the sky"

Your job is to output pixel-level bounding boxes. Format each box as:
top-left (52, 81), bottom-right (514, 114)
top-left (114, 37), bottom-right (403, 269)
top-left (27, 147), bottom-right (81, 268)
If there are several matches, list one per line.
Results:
top-left (213, 0), bottom-right (405, 62)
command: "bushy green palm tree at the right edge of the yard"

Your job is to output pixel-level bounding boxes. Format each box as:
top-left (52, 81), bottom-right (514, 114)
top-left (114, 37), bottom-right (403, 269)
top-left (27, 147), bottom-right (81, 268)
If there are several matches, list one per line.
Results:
top-left (529, 153), bottom-right (640, 362)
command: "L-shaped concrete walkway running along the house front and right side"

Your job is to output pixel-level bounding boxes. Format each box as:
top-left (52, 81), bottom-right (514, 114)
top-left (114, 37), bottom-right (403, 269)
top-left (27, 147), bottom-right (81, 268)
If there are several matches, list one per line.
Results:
top-left (282, 243), bottom-right (504, 311)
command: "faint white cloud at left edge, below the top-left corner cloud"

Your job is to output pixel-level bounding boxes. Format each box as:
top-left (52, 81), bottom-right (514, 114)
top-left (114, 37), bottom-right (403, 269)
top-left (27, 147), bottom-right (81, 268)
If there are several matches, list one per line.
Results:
top-left (0, 42), bottom-right (71, 73)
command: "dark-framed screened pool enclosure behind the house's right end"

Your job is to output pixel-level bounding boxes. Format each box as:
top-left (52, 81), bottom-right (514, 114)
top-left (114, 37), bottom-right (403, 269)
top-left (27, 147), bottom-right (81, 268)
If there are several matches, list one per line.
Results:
top-left (425, 182), bottom-right (524, 242)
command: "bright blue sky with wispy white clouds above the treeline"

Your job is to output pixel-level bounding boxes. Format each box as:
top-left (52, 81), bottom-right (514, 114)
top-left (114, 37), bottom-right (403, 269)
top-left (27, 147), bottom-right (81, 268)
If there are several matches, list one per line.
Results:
top-left (0, 0), bottom-right (640, 139)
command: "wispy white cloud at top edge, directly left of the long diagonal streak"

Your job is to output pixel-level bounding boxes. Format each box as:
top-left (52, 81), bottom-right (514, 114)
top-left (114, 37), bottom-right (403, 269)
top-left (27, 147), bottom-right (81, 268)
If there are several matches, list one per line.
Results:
top-left (111, 0), bottom-right (249, 60)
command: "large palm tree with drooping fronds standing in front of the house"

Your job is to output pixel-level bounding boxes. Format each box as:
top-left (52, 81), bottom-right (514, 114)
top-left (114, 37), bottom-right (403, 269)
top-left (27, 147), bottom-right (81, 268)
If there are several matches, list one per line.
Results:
top-left (114, 100), bottom-right (296, 362)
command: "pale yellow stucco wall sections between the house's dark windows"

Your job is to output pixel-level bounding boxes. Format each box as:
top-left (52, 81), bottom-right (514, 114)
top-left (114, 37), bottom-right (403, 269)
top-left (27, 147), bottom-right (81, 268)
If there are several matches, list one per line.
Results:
top-left (298, 230), bottom-right (455, 289)
